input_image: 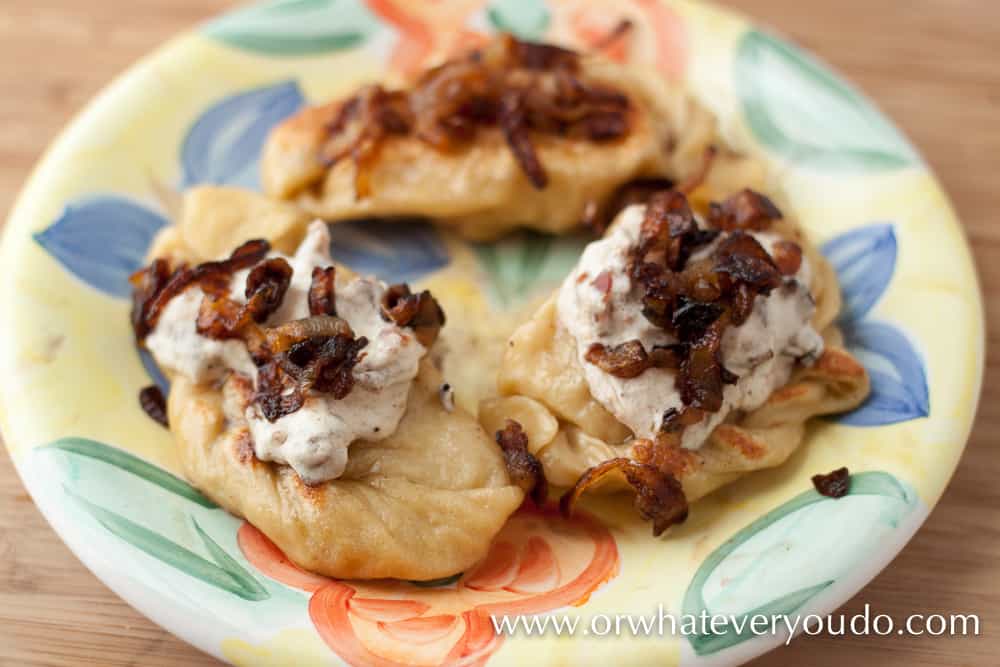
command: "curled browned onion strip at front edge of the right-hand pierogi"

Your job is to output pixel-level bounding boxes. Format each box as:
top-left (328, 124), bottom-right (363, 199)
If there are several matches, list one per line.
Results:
top-left (559, 458), bottom-right (688, 535)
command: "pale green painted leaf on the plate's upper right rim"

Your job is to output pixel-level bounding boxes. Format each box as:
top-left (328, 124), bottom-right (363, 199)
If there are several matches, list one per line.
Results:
top-left (735, 30), bottom-right (919, 171)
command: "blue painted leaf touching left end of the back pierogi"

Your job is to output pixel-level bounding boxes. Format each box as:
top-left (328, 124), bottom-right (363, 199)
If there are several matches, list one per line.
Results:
top-left (181, 81), bottom-right (305, 190)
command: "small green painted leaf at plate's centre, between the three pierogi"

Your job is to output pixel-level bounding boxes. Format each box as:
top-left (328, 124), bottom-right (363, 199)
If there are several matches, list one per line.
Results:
top-left (473, 231), bottom-right (590, 309)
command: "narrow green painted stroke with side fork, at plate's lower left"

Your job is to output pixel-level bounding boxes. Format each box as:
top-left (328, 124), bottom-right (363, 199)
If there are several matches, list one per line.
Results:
top-left (63, 486), bottom-right (270, 601)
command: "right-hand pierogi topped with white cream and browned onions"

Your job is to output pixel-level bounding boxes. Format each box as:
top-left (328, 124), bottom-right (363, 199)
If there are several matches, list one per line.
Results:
top-left (480, 192), bottom-right (869, 532)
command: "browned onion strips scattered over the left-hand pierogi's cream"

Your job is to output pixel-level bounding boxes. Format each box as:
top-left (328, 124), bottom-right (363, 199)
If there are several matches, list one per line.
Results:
top-left (130, 240), bottom-right (444, 422)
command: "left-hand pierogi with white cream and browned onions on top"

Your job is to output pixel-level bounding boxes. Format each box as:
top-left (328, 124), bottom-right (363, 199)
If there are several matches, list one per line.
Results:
top-left (134, 188), bottom-right (524, 580)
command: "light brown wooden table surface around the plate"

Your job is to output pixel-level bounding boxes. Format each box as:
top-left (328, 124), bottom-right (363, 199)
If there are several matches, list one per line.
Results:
top-left (0, 0), bottom-right (1000, 667)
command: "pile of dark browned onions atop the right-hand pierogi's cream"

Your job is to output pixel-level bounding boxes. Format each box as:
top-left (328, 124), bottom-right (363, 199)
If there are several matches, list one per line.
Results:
top-left (608, 190), bottom-right (801, 454)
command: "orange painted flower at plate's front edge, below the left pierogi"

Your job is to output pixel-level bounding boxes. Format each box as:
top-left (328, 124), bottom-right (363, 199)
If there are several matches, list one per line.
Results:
top-left (239, 502), bottom-right (618, 667)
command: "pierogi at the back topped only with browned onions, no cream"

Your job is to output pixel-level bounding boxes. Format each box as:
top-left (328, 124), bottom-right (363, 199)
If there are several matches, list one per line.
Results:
top-left (262, 37), bottom-right (760, 240)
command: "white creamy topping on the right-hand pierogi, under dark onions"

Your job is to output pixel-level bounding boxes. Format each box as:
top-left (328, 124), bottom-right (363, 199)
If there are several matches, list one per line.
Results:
top-left (557, 206), bottom-right (823, 449)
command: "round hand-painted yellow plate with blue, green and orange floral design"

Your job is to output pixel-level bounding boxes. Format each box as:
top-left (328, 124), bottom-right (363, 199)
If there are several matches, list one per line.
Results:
top-left (0, 0), bottom-right (983, 665)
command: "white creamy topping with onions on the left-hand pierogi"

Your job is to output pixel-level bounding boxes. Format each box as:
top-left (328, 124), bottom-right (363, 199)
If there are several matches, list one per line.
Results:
top-left (146, 220), bottom-right (427, 484)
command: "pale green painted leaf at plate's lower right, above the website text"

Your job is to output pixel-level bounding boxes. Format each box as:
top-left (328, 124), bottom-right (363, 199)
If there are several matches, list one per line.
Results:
top-left (683, 472), bottom-right (918, 655)
